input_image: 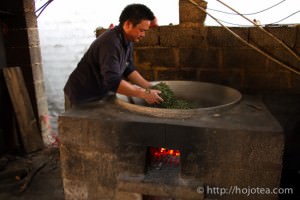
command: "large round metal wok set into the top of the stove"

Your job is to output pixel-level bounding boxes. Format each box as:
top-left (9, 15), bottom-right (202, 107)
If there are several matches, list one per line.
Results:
top-left (116, 81), bottom-right (242, 118)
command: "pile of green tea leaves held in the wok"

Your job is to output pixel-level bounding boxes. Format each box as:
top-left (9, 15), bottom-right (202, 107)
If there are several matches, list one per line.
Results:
top-left (151, 82), bottom-right (195, 109)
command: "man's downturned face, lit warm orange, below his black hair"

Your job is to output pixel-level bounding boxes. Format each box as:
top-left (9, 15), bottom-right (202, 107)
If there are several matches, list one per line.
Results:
top-left (123, 20), bottom-right (151, 42)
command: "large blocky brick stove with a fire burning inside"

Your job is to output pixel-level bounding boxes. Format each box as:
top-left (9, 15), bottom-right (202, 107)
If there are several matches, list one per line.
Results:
top-left (59, 81), bottom-right (284, 200)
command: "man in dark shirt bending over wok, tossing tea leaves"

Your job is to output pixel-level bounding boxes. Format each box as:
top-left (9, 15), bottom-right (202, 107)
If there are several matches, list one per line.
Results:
top-left (64, 4), bottom-right (163, 108)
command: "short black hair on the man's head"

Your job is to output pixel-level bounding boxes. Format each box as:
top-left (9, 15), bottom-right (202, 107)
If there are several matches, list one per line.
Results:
top-left (119, 4), bottom-right (154, 26)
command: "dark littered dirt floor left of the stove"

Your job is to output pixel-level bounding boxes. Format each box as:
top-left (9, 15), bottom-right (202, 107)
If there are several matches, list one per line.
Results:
top-left (0, 148), bottom-right (64, 200)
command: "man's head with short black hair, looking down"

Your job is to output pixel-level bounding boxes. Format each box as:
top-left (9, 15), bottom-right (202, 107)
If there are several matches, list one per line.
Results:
top-left (119, 4), bottom-right (155, 42)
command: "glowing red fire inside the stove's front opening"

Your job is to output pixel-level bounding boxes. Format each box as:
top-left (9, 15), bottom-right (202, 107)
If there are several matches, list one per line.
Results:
top-left (149, 147), bottom-right (180, 168)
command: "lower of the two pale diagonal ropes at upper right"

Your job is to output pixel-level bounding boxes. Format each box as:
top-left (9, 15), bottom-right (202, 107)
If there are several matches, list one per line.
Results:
top-left (188, 0), bottom-right (300, 75)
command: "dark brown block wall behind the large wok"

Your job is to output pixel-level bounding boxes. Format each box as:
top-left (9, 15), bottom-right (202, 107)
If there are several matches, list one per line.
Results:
top-left (134, 25), bottom-right (300, 93)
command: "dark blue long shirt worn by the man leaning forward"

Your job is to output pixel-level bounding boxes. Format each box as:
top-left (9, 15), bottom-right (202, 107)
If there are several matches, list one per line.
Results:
top-left (64, 26), bottom-right (135, 104)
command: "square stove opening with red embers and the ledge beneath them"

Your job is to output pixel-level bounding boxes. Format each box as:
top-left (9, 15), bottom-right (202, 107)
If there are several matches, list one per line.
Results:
top-left (143, 147), bottom-right (180, 200)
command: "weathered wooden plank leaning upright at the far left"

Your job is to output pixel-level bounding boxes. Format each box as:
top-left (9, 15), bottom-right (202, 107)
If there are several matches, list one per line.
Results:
top-left (3, 67), bottom-right (43, 153)
